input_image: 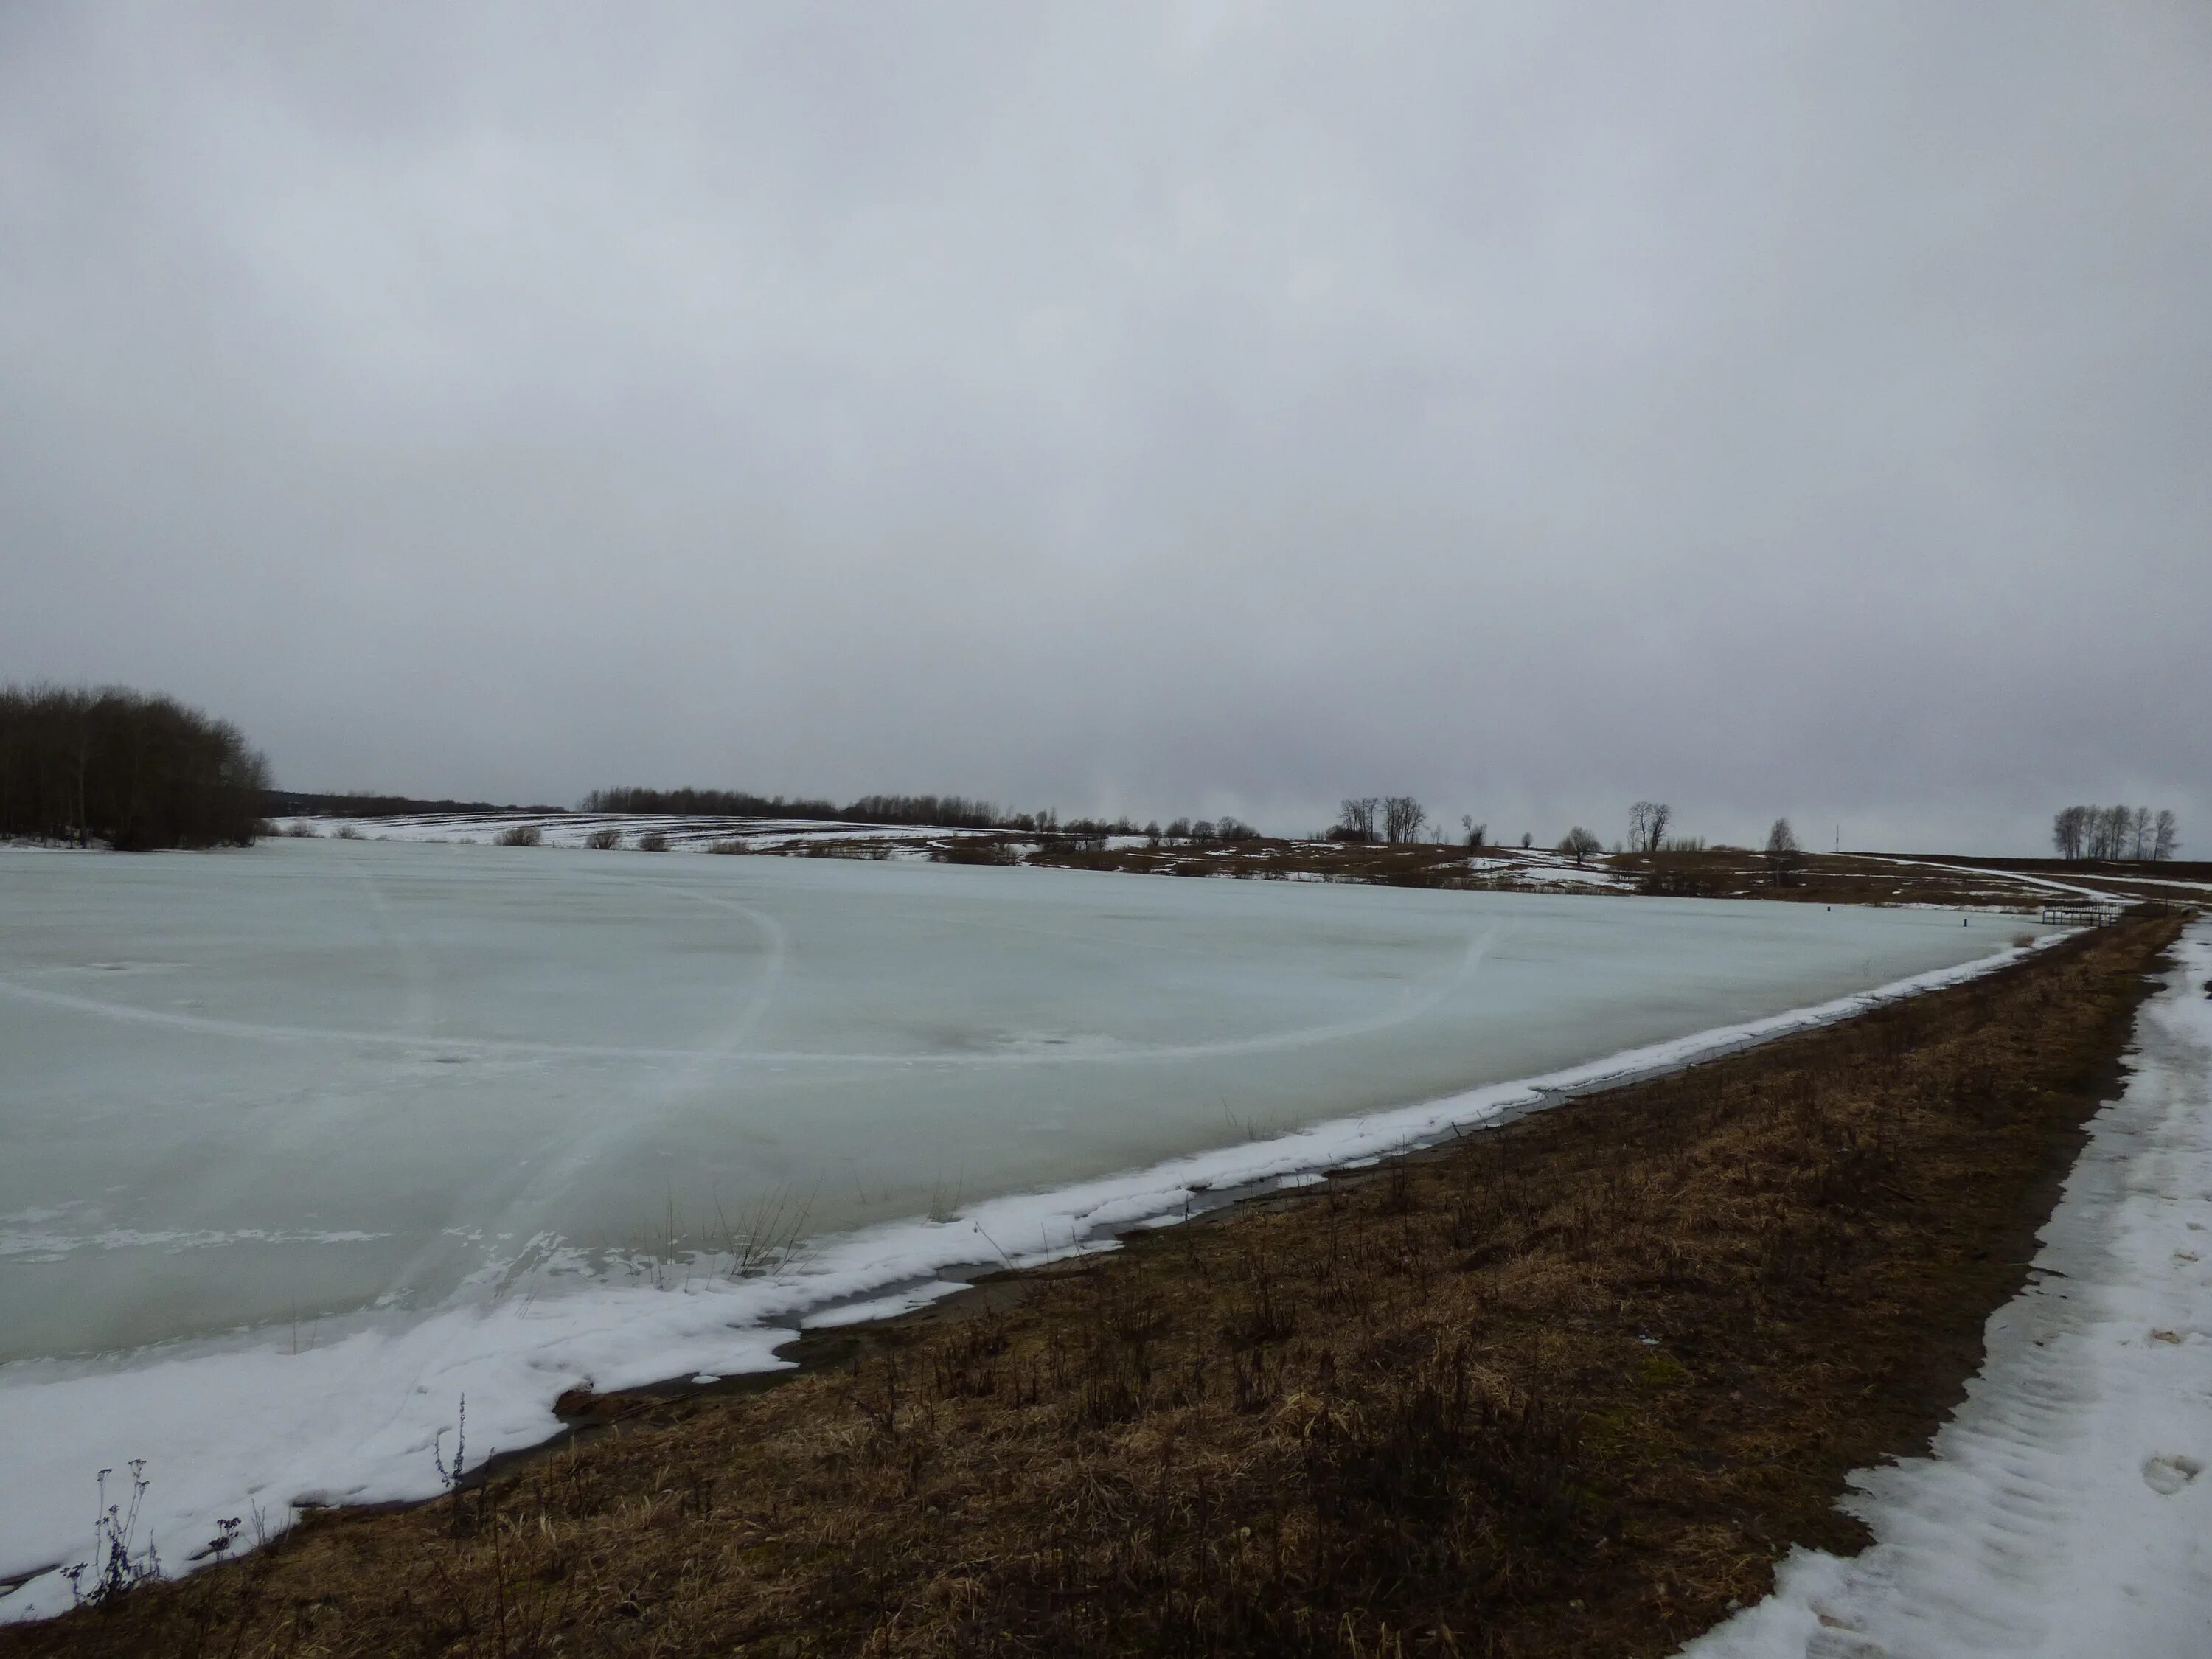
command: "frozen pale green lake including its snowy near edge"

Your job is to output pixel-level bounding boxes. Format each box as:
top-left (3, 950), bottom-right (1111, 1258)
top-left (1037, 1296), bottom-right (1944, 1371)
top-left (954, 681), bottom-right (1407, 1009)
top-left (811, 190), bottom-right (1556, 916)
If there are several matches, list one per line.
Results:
top-left (0, 841), bottom-right (2035, 1613)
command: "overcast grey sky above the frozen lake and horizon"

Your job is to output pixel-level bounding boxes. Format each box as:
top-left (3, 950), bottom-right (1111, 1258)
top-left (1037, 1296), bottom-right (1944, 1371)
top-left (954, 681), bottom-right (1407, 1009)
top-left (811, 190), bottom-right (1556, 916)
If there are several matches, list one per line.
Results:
top-left (0, 0), bottom-right (2212, 856)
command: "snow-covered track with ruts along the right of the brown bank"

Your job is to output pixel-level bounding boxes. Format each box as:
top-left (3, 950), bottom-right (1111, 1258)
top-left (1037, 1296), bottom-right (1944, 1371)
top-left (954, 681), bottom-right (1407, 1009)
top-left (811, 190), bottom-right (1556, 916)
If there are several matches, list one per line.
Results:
top-left (1683, 920), bottom-right (2212, 1659)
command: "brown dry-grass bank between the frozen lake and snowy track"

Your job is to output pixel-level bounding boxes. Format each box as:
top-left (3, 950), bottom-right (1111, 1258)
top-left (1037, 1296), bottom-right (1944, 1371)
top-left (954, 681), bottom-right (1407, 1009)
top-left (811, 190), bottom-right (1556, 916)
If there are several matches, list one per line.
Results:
top-left (0, 922), bottom-right (2177, 1657)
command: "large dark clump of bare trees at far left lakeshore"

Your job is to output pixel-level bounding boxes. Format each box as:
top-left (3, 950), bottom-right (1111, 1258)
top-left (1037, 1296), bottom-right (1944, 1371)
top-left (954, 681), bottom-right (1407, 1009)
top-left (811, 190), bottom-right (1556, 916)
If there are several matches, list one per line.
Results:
top-left (0, 686), bottom-right (268, 852)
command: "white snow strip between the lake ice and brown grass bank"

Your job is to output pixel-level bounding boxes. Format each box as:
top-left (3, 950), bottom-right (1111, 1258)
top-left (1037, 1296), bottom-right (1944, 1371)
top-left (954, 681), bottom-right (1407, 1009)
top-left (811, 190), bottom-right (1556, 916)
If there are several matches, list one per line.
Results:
top-left (0, 936), bottom-right (2064, 1621)
